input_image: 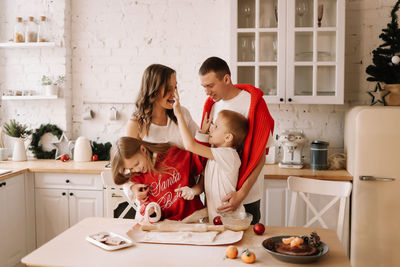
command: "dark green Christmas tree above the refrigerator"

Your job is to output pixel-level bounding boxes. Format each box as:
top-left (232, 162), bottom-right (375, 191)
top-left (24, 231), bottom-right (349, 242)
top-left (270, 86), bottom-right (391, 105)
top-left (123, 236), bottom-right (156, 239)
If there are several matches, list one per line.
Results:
top-left (366, 0), bottom-right (400, 84)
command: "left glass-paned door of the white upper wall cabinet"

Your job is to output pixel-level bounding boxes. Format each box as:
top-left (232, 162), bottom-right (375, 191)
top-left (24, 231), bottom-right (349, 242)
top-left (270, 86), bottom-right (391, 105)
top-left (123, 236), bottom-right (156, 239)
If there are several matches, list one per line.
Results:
top-left (232, 0), bottom-right (286, 103)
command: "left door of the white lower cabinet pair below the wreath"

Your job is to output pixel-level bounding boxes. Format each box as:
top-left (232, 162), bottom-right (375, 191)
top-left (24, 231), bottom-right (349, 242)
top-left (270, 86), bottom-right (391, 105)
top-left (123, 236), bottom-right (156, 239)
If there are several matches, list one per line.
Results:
top-left (35, 188), bottom-right (69, 247)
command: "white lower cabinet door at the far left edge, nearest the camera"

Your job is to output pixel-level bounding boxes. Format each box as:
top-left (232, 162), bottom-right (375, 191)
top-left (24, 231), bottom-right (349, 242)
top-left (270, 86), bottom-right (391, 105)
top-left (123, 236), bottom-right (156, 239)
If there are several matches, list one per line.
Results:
top-left (0, 174), bottom-right (28, 267)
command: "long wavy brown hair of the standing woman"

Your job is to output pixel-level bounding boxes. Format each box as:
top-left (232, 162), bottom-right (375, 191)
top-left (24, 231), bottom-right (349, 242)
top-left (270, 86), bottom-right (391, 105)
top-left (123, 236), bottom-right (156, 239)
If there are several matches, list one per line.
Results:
top-left (132, 64), bottom-right (177, 137)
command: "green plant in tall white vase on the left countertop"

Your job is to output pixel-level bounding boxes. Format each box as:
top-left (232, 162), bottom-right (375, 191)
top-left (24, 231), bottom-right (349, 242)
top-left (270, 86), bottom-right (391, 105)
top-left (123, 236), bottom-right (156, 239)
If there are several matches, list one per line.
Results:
top-left (3, 119), bottom-right (32, 161)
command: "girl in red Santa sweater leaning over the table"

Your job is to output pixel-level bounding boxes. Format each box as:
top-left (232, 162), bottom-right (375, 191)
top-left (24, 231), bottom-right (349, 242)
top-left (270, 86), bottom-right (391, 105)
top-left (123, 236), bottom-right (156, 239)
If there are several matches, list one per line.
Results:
top-left (111, 137), bottom-right (204, 223)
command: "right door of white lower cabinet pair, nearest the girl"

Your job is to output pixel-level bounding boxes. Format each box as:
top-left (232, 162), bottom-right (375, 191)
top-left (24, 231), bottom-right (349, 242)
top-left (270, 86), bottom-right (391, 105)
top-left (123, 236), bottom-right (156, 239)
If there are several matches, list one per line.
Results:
top-left (69, 190), bottom-right (103, 226)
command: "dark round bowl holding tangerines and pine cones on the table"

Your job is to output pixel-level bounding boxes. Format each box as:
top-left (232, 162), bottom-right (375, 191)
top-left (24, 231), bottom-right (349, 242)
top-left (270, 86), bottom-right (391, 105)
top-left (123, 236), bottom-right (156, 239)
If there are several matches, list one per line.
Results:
top-left (262, 235), bottom-right (328, 263)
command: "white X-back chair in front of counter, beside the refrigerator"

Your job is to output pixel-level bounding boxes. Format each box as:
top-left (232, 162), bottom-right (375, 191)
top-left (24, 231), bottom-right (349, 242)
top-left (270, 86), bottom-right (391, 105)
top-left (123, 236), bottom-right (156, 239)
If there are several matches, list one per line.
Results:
top-left (288, 176), bottom-right (352, 241)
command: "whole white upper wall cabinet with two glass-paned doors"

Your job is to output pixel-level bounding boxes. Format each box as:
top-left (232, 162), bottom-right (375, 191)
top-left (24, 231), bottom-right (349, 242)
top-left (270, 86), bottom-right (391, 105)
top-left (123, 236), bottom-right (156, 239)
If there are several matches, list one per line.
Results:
top-left (231, 0), bottom-right (345, 104)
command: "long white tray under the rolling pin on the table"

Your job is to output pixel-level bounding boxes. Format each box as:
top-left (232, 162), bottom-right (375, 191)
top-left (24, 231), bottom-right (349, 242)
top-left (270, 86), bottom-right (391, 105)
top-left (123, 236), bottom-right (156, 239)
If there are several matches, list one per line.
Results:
top-left (127, 227), bottom-right (243, 246)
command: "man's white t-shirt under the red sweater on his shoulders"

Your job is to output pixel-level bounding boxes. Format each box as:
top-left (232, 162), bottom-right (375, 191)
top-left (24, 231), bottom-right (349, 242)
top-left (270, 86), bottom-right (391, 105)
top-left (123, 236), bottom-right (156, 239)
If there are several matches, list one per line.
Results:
top-left (210, 90), bottom-right (266, 204)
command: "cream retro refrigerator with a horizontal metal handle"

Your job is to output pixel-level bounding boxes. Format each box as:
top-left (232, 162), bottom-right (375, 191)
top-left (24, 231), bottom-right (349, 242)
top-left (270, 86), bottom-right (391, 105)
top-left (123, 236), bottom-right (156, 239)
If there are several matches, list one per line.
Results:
top-left (344, 106), bottom-right (400, 267)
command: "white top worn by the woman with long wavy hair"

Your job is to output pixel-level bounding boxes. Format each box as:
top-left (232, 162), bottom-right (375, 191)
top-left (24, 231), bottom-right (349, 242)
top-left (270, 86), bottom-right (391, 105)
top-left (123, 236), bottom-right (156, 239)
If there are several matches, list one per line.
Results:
top-left (143, 107), bottom-right (199, 149)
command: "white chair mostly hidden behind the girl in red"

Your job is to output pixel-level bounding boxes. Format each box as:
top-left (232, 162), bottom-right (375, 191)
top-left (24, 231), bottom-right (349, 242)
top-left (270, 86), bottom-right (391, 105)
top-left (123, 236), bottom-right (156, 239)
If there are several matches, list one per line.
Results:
top-left (101, 171), bottom-right (139, 218)
